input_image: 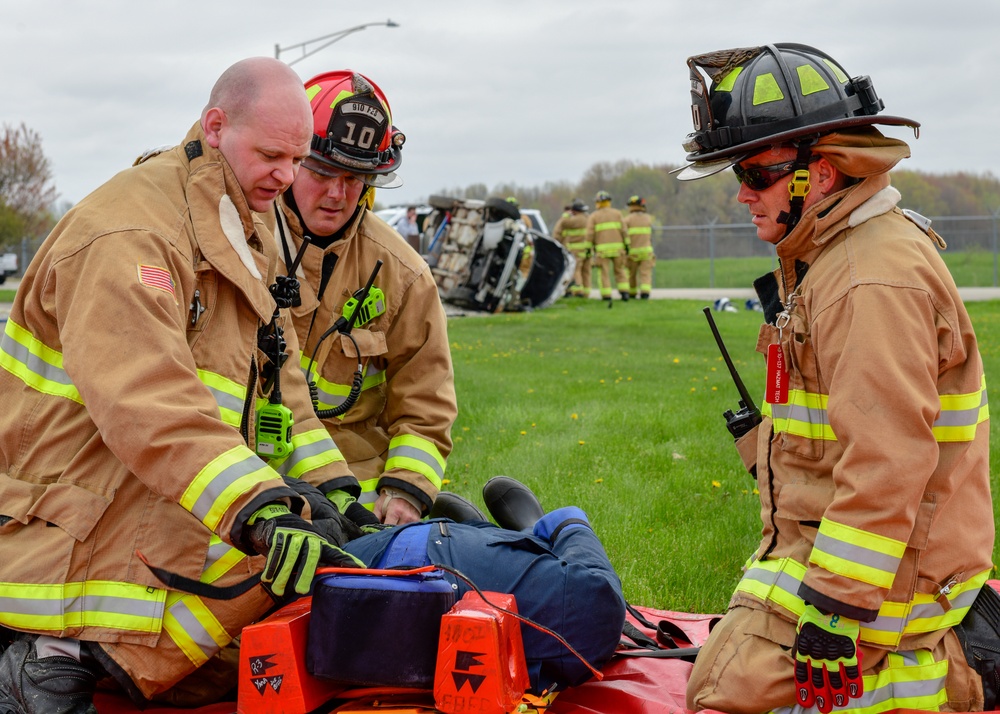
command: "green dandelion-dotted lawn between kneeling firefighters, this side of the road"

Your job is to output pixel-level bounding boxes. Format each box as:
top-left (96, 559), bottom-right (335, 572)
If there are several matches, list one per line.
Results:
top-left (446, 298), bottom-right (1000, 612)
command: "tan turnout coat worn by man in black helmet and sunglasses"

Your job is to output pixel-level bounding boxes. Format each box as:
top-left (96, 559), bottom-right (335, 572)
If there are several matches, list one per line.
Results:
top-left (732, 174), bottom-right (994, 650)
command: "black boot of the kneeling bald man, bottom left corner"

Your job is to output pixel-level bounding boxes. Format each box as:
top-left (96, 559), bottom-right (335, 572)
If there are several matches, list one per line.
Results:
top-left (0, 637), bottom-right (97, 714)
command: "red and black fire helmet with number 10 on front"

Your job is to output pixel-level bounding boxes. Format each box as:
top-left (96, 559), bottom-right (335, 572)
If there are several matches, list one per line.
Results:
top-left (306, 70), bottom-right (405, 188)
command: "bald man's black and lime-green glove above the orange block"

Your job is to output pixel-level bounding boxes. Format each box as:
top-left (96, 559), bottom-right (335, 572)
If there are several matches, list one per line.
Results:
top-left (248, 503), bottom-right (365, 598)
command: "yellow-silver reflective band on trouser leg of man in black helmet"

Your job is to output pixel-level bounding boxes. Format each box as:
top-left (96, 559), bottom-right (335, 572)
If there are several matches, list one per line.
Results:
top-left (773, 650), bottom-right (948, 714)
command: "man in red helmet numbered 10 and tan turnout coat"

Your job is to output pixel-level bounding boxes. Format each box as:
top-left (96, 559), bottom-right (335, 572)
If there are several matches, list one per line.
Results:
top-left (266, 70), bottom-right (457, 525)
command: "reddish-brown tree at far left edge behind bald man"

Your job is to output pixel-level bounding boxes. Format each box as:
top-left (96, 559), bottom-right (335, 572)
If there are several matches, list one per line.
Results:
top-left (0, 123), bottom-right (58, 245)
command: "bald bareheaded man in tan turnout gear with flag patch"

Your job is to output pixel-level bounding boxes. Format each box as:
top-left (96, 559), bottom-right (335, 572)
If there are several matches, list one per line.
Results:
top-left (0, 58), bottom-right (357, 713)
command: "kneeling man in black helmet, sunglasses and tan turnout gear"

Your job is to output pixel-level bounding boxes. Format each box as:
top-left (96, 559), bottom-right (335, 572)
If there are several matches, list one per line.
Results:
top-left (678, 44), bottom-right (1000, 712)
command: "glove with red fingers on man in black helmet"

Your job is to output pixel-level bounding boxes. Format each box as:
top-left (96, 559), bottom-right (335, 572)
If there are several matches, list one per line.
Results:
top-left (792, 604), bottom-right (864, 713)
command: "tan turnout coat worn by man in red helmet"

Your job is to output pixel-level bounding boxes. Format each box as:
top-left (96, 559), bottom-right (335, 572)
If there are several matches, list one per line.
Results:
top-left (274, 201), bottom-right (458, 513)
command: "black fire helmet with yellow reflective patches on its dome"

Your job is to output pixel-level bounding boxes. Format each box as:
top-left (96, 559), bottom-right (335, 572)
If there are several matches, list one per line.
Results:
top-left (678, 43), bottom-right (920, 180)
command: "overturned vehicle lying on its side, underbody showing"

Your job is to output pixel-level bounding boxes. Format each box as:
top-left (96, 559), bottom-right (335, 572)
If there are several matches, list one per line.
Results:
top-left (423, 196), bottom-right (576, 313)
